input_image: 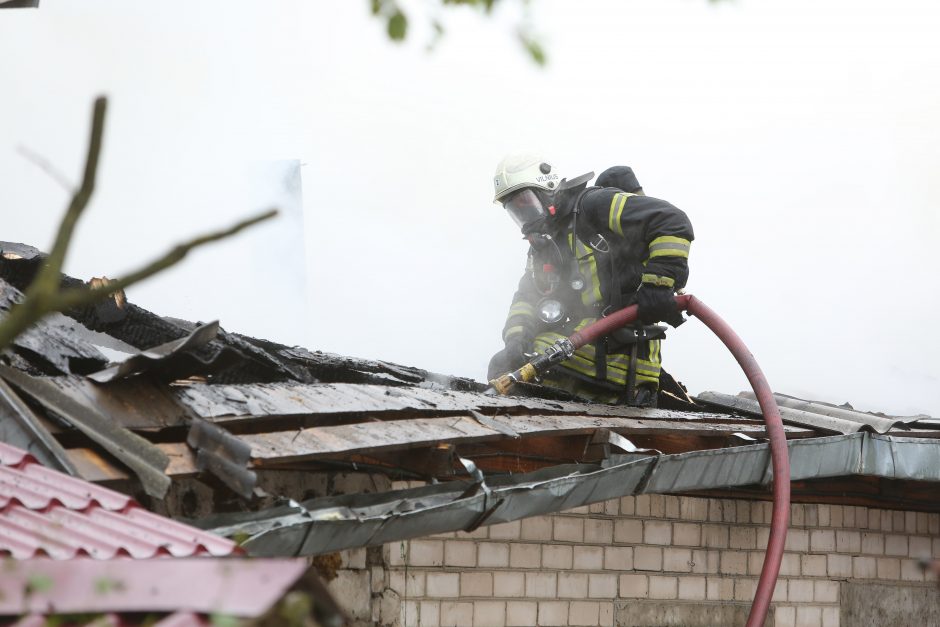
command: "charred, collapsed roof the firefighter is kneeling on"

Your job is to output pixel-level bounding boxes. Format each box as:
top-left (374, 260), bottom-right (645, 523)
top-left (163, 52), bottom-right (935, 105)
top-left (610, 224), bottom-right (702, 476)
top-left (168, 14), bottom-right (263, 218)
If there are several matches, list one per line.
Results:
top-left (0, 243), bottom-right (940, 550)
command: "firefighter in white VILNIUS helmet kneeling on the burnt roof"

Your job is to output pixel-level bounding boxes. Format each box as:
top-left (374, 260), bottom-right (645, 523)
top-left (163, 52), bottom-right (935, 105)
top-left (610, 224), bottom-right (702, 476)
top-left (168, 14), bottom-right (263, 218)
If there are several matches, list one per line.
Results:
top-left (488, 155), bottom-right (693, 407)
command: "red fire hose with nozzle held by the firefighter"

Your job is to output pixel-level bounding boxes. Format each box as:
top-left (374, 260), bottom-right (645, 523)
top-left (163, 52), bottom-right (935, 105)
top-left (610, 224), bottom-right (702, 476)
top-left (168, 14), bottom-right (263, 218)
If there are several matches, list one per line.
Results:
top-left (491, 294), bottom-right (790, 627)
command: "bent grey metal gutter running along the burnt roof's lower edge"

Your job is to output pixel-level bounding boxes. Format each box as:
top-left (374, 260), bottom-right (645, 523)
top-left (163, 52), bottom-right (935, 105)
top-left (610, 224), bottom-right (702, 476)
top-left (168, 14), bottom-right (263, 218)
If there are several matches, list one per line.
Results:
top-left (200, 433), bottom-right (940, 556)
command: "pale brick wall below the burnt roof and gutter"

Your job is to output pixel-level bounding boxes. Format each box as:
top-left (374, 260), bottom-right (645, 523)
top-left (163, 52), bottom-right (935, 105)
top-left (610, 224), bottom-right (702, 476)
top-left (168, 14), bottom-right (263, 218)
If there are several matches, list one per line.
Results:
top-left (330, 495), bottom-right (940, 627)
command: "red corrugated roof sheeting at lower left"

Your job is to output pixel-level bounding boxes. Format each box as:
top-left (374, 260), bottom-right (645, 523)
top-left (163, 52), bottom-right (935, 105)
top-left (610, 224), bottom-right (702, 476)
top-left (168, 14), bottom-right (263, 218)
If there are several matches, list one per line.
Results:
top-left (0, 442), bottom-right (238, 559)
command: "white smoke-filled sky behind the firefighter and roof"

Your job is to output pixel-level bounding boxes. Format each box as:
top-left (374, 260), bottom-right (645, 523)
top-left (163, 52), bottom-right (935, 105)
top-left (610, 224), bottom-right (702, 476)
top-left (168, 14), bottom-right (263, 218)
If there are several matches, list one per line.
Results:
top-left (0, 0), bottom-right (940, 416)
